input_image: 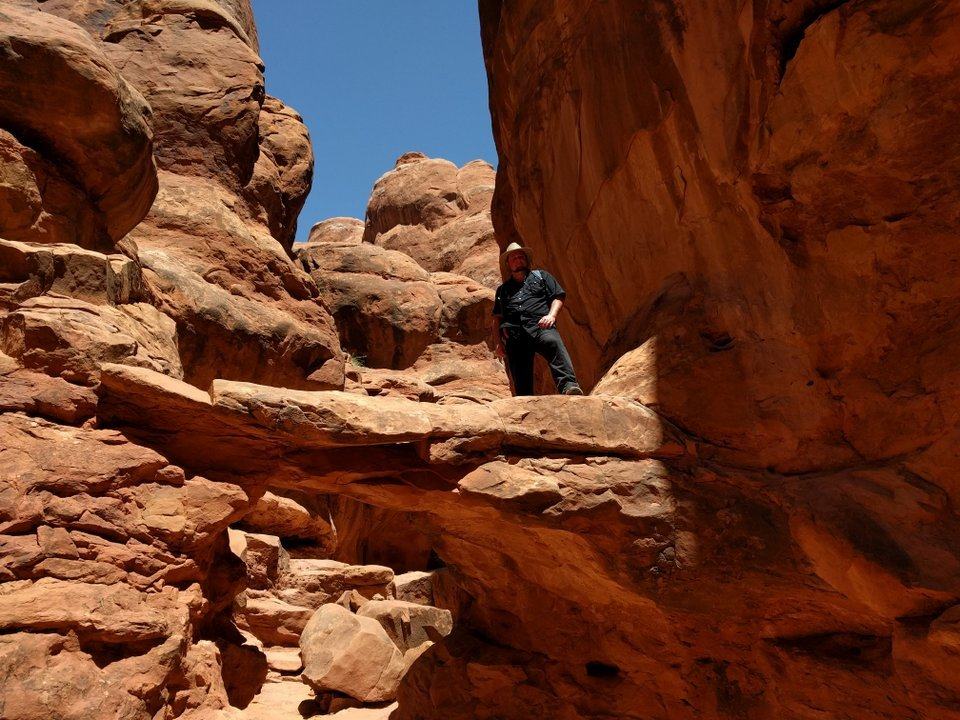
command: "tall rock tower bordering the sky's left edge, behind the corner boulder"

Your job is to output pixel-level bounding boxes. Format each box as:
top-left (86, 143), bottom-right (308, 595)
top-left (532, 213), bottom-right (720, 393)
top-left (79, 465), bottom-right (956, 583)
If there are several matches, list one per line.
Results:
top-left (23, 0), bottom-right (343, 388)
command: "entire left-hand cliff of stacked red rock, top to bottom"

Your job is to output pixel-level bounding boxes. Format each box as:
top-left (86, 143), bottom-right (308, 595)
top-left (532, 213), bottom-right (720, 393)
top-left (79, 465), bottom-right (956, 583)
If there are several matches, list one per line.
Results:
top-left (0, 0), bottom-right (344, 720)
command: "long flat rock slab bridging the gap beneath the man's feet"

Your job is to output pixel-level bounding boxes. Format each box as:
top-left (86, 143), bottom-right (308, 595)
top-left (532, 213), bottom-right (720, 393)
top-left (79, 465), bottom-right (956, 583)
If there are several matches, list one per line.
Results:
top-left (99, 364), bottom-right (685, 471)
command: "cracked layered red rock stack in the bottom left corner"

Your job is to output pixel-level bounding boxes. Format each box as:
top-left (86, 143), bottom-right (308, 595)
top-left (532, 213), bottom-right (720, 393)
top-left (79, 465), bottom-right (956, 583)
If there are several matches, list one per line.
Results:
top-left (0, 413), bottom-right (255, 718)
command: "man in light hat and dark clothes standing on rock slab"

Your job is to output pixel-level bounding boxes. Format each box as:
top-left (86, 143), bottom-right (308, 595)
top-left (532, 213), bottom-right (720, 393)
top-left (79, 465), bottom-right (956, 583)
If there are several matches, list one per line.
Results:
top-left (493, 243), bottom-right (583, 395)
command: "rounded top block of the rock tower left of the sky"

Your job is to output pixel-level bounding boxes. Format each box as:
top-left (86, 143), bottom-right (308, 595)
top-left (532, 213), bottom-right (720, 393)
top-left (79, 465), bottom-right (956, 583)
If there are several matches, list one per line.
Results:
top-left (103, 0), bottom-right (263, 188)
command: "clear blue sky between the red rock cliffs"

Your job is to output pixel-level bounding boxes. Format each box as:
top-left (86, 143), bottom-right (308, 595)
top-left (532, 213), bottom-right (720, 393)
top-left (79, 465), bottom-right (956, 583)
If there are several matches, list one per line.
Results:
top-left (253, 0), bottom-right (496, 240)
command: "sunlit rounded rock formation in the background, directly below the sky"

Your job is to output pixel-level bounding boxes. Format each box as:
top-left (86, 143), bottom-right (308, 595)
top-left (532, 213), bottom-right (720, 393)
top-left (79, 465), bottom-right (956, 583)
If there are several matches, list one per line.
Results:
top-left (297, 153), bottom-right (509, 402)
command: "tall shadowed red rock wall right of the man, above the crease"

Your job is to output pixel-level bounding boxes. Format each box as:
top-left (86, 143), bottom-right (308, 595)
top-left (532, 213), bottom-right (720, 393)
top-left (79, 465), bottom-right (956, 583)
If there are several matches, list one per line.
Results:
top-left (480, 0), bottom-right (960, 471)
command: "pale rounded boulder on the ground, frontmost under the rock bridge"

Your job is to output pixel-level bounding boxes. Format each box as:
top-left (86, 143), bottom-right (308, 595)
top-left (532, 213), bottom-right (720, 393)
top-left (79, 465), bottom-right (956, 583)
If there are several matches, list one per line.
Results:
top-left (300, 605), bottom-right (404, 702)
